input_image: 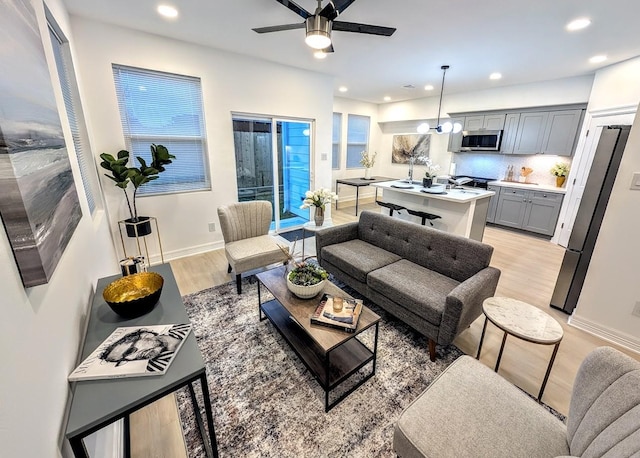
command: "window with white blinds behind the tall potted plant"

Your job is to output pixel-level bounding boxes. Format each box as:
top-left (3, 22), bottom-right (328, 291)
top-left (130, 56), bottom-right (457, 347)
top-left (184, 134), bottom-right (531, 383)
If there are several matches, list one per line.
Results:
top-left (113, 64), bottom-right (211, 194)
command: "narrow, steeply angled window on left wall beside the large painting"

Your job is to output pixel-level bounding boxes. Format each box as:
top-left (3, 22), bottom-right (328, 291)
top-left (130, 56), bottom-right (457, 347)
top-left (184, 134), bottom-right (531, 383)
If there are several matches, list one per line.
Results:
top-left (47, 17), bottom-right (99, 215)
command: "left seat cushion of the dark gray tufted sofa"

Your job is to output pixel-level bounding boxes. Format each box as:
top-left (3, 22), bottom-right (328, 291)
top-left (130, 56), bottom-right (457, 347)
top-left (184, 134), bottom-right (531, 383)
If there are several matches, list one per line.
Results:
top-left (322, 239), bottom-right (400, 283)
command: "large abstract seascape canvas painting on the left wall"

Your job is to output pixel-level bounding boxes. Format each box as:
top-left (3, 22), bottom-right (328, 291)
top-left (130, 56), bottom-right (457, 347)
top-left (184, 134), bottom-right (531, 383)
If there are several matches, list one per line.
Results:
top-left (0, 0), bottom-right (82, 287)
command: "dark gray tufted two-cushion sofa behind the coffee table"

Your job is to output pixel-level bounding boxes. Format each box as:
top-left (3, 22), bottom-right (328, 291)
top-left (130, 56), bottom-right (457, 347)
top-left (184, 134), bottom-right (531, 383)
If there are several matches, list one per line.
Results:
top-left (316, 211), bottom-right (500, 361)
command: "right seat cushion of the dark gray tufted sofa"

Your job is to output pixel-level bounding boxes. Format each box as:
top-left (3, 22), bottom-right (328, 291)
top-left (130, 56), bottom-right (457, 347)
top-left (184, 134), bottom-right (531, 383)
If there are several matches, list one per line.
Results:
top-left (367, 259), bottom-right (460, 326)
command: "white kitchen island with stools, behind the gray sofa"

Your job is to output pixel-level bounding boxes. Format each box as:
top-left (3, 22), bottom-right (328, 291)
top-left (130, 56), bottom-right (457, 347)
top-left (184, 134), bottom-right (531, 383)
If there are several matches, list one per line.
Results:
top-left (371, 181), bottom-right (495, 241)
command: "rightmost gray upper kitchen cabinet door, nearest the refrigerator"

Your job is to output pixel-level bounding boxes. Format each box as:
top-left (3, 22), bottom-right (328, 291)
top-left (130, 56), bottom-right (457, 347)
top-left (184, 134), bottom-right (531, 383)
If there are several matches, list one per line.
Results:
top-left (541, 110), bottom-right (583, 156)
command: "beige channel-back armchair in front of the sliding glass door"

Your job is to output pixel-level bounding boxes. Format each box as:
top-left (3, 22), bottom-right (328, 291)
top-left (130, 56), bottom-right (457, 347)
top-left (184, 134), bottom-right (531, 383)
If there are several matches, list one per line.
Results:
top-left (218, 200), bottom-right (289, 294)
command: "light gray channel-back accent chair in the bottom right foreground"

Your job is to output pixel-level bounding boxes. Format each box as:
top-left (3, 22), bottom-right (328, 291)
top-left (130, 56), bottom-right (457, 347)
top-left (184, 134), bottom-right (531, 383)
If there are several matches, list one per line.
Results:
top-left (393, 347), bottom-right (640, 458)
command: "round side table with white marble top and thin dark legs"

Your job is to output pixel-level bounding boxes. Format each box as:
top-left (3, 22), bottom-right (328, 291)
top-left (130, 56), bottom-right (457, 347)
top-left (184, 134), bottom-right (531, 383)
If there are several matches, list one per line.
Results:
top-left (476, 297), bottom-right (564, 400)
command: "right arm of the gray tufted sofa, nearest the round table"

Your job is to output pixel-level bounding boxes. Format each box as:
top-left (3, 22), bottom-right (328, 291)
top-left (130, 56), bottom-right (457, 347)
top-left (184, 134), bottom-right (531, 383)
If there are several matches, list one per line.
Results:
top-left (438, 267), bottom-right (500, 345)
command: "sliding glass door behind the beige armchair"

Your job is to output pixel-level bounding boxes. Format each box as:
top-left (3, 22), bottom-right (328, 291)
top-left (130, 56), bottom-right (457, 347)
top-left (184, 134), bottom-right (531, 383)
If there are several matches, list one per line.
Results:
top-left (233, 115), bottom-right (312, 231)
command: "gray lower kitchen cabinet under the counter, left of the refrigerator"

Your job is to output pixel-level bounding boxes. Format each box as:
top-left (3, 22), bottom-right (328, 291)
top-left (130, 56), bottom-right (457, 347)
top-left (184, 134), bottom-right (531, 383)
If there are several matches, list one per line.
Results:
top-left (494, 188), bottom-right (564, 236)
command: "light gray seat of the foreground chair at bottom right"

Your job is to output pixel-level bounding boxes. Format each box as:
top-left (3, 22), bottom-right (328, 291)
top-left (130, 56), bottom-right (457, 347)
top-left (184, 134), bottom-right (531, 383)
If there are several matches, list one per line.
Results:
top-left (393, 356), bottom-right (569, 458)
